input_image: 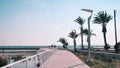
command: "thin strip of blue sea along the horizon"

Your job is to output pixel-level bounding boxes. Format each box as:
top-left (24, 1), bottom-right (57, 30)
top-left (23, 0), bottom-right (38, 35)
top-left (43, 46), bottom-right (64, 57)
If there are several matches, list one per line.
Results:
top-left (0, 45), bottom-right (114, 49)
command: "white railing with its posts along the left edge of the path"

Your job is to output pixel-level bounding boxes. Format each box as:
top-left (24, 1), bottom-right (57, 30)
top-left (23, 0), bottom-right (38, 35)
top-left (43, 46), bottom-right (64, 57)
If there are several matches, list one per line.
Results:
top-left (1, 49), bottom-right (55, 68)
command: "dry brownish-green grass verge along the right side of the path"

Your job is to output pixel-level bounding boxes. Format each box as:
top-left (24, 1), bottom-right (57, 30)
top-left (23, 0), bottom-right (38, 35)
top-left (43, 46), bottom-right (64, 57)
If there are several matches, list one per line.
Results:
top-left (72, 51), bottom-right (120, 68)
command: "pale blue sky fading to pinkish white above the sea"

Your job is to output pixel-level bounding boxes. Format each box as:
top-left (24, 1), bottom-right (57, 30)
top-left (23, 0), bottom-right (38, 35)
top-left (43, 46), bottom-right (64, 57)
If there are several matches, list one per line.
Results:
top-left (0, 0), bottom-right (120, 45)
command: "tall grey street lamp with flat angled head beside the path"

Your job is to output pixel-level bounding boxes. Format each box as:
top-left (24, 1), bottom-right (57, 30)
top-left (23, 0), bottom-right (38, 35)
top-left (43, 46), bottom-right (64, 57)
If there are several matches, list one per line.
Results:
top-left (81, 9), bottom-right (93, 62)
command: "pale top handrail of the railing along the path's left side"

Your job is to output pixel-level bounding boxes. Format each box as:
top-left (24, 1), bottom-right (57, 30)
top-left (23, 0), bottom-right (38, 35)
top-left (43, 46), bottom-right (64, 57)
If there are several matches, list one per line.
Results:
top-left (1, 49), bottom-right (52, 68)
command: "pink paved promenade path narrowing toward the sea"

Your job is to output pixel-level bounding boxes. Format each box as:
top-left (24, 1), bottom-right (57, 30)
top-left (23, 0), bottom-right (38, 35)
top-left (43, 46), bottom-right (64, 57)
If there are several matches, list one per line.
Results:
top-left (41, 50), bottom-right (90, 68)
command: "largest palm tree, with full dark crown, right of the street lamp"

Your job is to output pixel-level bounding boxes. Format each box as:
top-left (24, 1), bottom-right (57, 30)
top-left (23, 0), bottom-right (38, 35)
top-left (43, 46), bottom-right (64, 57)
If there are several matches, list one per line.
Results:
top-left (93, 11), bottom-right (112, 50)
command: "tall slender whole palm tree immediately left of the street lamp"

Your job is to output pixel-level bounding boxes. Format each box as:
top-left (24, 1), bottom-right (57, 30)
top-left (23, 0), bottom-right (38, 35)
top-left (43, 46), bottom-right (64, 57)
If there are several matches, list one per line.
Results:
top-left (75, 17), bottom-right (85, 49)
